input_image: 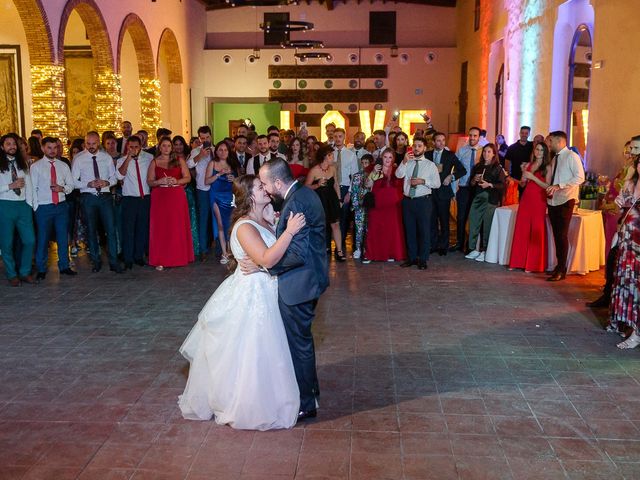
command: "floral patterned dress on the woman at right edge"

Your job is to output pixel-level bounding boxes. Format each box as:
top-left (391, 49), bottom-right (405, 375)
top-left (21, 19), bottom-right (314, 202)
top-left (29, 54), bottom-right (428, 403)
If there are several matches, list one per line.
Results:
top-left (611, 201), bottom-right (640, 333)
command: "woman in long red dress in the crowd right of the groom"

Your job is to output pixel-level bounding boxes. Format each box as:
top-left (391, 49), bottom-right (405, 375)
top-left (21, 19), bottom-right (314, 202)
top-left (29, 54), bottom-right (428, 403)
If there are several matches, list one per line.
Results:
top-left (363, 148), bottom-right (407, 263)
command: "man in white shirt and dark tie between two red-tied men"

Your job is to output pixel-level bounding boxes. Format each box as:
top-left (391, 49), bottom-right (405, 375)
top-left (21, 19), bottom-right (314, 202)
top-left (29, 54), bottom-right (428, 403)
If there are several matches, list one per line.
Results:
top-left (71, 131), bottom-right (123, 273)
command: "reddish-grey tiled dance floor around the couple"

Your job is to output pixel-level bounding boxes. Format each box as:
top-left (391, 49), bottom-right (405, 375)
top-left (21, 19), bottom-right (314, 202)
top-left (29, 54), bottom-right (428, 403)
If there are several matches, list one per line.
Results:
top-left (0, 251), bottom-right (640, 480)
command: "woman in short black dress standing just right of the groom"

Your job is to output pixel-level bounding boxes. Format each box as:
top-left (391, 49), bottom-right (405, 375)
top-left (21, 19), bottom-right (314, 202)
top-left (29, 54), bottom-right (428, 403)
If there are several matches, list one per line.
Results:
top-left (305, 145), bottom-right (346, 262)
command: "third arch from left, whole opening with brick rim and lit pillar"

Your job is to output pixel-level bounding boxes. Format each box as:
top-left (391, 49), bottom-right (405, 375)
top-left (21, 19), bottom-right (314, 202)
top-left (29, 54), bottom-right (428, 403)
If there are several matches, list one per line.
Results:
top-left (117, 13), bottom-right (161, 134)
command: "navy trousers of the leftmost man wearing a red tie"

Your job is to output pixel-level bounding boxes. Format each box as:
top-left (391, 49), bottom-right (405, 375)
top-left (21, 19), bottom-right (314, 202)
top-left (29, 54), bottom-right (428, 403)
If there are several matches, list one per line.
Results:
top-left (36, 202), bottom-right (69, 272)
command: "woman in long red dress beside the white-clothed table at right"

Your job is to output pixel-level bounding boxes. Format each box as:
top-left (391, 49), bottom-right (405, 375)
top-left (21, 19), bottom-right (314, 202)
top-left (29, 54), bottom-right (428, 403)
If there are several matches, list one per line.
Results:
top-left (509, 143), bottom-right (551, 272)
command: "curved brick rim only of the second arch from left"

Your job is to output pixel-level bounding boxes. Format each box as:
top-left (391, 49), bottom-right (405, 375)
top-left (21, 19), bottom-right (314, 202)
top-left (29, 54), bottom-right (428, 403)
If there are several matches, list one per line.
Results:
top-left (58, 0), bottom-right (114, 73)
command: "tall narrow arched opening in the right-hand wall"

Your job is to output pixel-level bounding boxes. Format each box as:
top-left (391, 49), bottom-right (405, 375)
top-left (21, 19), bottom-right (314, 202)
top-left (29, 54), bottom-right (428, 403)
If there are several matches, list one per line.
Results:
top-left (566, 24), bottom-right (593, 158)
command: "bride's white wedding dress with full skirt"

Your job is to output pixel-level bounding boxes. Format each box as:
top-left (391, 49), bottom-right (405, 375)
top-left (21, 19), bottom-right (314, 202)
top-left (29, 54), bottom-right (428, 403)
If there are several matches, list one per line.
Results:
top-left (178, 220), bottom-right (300, 430)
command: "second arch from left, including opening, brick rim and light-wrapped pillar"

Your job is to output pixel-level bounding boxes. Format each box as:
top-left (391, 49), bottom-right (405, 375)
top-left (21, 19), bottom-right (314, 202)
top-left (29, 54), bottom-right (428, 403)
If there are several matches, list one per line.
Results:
top-left (58, 0), bottom-right (122, 136)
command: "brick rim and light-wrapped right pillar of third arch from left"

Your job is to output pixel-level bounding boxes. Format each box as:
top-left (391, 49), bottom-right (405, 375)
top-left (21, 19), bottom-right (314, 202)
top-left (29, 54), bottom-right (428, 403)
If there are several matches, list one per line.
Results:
top-left (116, 13), bottom-right (160, 132)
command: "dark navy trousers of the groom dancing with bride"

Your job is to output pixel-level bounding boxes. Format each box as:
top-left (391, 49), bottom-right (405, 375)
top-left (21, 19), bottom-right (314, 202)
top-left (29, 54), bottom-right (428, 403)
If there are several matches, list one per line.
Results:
top-left (278, 298), bottom-right (318, 412)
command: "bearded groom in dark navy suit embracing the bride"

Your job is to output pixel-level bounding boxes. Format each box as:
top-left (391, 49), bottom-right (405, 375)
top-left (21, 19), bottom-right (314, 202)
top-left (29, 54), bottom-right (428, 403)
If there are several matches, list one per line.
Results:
top-left (259, 158), bottom-right (329, 420)
